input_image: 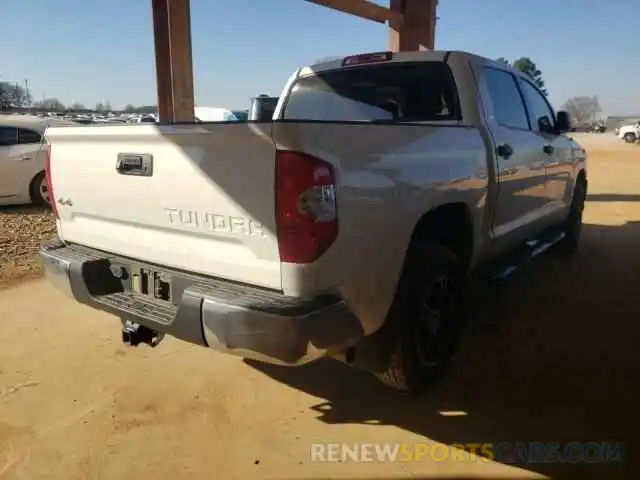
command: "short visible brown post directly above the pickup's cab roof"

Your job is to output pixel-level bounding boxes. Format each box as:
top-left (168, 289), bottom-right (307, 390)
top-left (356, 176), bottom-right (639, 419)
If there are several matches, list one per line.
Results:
top-left (389, 0), bottom-right (438, 52)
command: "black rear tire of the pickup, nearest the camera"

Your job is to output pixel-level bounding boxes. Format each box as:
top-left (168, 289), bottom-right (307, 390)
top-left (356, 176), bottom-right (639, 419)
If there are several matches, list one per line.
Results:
top-left (376, 245), bottom-right (465, 393)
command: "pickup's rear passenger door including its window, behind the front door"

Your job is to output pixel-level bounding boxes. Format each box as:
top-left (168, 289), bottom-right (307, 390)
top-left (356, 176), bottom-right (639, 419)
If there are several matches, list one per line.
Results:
top-left (480, 67), bottom-right (549, 248)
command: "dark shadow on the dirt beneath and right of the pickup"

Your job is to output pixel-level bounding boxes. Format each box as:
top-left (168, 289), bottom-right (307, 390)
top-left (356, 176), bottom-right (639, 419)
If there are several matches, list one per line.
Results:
top-left (246, 222), bottom-right (640, 480)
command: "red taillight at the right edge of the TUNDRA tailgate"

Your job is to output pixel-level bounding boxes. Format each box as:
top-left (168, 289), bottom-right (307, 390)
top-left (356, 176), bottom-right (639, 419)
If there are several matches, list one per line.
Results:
top-left (276, 151), bottom-right (338, 263)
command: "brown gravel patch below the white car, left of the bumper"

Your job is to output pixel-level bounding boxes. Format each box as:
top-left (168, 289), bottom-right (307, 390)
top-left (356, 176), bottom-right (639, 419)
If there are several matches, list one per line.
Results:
top-left (0, 207), bottom-right (56, 288)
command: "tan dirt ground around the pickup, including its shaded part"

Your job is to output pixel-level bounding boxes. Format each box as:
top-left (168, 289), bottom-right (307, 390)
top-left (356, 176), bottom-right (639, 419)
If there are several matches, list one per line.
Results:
top-left (0, 135), bottom-right (640, 480)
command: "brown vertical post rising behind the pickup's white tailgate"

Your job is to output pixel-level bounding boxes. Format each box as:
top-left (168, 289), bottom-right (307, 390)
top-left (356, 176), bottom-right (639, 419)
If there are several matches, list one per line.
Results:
top-left (151, 0), bottom-right (194, 122)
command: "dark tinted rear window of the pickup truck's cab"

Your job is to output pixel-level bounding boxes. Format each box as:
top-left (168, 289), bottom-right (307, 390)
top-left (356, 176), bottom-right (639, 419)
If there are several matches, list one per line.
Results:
top-left (282, 61), bottom-right (461, 122)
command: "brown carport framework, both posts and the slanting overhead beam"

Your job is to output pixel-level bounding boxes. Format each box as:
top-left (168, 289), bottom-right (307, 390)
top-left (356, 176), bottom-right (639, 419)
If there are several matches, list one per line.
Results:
top-left (151, 0), bottom-right (438, 122)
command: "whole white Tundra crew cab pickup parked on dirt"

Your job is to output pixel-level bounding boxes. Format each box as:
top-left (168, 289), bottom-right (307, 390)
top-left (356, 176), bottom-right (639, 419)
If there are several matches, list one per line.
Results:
top-left (41, 51), bottom-right (587, 391)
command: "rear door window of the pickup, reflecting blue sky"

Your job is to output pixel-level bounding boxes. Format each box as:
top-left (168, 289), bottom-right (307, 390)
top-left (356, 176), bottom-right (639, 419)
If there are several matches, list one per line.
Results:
top-left (484, 68), bottom-right (530, 130)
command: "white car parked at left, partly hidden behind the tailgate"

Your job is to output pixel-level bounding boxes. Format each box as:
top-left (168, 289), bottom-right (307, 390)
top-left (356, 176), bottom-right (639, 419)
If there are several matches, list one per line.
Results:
top-left (0, 115), bottom-right (75, 206)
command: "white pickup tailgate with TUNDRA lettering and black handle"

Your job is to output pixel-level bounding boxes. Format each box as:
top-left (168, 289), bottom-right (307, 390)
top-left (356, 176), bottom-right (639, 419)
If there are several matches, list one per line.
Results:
top-left (46, 123), bottom-right (282, 290)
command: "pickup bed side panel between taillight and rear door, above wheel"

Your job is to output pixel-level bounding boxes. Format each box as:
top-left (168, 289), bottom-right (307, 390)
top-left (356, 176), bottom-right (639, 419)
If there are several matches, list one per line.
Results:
top-left (274, 122), bottom-right (489, 333)
